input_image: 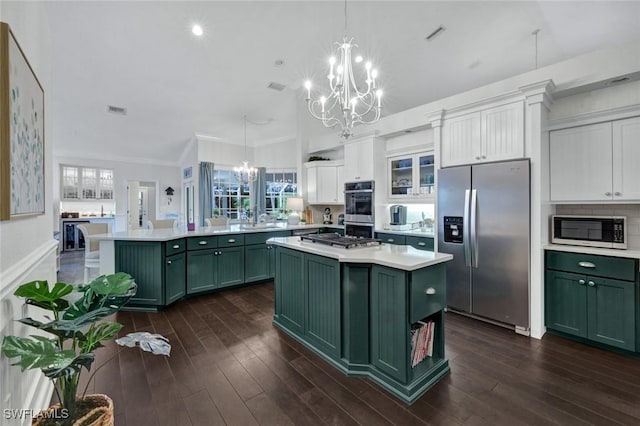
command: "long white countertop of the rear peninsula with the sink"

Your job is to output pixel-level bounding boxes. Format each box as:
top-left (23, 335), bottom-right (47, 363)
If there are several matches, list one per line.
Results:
top-left (91, 223), bottom-right (335, 241)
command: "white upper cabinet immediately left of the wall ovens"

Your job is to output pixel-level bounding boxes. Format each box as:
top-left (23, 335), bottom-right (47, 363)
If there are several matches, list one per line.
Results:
top-left (304, 161), bottom-right (345, 204)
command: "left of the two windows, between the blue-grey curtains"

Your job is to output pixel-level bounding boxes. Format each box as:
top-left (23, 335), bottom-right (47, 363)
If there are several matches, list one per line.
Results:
top-left (213, 170), bottom-right (250, 219)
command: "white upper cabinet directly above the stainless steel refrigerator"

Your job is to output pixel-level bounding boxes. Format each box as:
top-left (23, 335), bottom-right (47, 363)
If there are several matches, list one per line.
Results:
top-left (440, 101), bottom-right (524, 167)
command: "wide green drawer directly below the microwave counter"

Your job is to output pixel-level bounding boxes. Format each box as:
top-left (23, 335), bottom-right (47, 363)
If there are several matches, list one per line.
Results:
top-left (546, 251), bottom-right (637, 281)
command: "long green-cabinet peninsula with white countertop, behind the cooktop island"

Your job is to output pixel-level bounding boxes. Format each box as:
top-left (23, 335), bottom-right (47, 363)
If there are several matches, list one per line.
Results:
top-left (92, 223), bottom-right (334, 310)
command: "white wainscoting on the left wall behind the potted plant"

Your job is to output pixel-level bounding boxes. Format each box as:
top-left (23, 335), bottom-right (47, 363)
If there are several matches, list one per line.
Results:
top-left (0, 240), bottom-right (58, 425)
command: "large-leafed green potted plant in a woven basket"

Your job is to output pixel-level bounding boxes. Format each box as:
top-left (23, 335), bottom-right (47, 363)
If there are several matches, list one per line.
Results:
top-left (2, 272), bottom-right (171, 425)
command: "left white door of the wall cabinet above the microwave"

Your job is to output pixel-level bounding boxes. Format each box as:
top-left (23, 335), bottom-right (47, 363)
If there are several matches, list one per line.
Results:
top-left (549, 123), bottom-right (613, 201)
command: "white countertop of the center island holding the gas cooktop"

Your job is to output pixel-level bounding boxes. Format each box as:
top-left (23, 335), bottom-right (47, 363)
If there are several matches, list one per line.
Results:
top-left (268, 237), bottom-right (453, 271)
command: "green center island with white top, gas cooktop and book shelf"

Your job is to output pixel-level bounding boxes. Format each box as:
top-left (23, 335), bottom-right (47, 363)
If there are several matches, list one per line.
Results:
top-left (267, 237), bottom-right (453, 404)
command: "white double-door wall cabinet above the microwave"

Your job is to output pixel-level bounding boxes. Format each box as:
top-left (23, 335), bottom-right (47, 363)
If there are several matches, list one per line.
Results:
top-left (549, 117), bottom-right (640, 202)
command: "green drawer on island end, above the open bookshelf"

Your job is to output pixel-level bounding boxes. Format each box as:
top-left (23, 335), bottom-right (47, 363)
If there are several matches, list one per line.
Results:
top-left (409, 263), bottom-right (447, 323)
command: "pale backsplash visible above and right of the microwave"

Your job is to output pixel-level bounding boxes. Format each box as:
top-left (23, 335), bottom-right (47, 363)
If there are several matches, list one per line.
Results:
top-left (556, 204), bottom-right (640, 249)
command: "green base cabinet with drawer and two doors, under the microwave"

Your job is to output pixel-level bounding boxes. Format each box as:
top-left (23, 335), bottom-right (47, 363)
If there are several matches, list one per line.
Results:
top-left (545, 251), bottom-right (638, 351)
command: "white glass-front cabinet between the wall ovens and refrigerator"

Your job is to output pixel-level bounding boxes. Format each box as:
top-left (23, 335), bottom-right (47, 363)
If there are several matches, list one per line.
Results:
top-left (389, 151), bottom-right (435, 199)
